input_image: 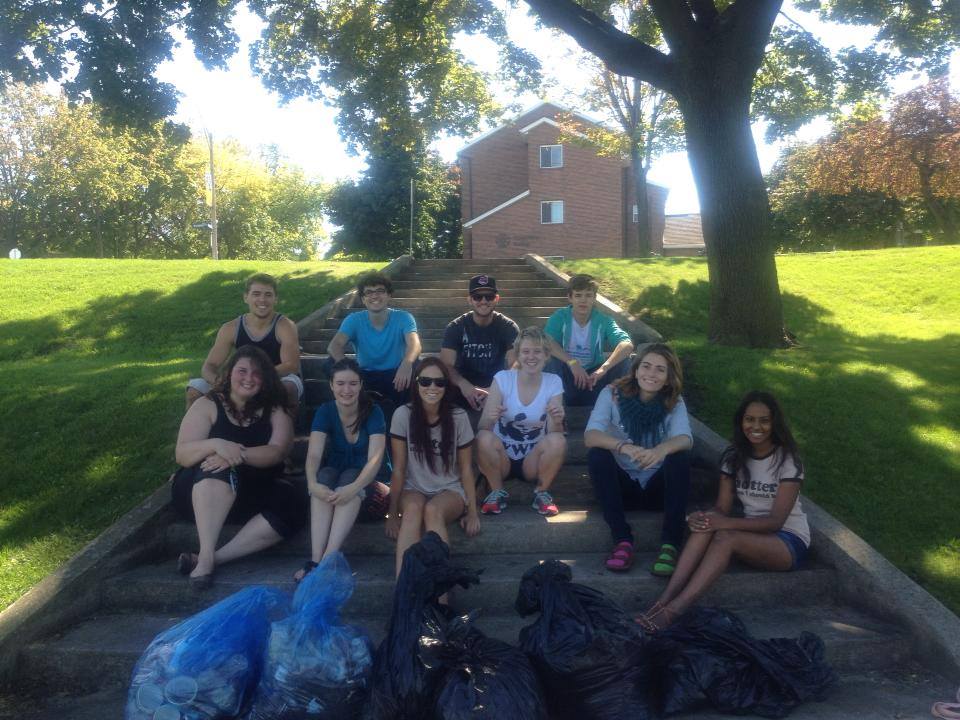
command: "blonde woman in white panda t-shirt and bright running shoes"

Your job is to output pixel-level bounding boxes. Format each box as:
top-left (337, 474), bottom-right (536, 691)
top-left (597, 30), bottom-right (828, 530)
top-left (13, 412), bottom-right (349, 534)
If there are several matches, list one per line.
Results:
top-left (477, 327), bottom-right (567, 516)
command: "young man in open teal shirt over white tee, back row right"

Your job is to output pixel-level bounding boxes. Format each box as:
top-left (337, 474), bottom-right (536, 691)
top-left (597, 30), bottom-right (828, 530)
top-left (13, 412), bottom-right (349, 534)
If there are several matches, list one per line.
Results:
top-left (544, 275), bottom-right (633, 406)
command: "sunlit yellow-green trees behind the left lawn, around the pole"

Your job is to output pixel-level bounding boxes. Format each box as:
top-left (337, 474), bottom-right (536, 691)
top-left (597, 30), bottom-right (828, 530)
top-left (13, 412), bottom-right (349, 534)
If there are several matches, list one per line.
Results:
top-left (0, 85), bottom-right (322, 259)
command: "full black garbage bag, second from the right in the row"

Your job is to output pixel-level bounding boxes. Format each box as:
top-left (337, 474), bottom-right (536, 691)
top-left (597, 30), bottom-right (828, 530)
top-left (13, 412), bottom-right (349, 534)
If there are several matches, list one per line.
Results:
top-left (516, 560), bottom-right (654, 720)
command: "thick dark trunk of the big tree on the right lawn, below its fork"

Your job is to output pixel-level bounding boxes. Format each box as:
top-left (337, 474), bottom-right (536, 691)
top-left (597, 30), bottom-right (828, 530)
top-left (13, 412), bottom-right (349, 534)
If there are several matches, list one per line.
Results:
top-left (678, 81), bottom-right (786, 347)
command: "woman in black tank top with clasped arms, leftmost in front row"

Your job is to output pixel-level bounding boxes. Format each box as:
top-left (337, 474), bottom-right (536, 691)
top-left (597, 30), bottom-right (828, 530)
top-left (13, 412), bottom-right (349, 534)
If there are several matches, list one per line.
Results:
top-left (172, 345), bottom-right (304, 589)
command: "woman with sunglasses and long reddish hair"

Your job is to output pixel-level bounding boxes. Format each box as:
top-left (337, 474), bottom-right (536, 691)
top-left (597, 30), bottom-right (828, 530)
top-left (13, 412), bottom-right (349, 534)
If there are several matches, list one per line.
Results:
top-left (386, 357), bottom-right (480, 575)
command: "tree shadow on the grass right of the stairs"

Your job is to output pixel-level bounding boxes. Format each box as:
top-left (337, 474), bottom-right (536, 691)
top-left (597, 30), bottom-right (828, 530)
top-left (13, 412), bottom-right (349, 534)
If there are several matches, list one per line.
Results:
top-left (629, 281), bottom-right (960, 612)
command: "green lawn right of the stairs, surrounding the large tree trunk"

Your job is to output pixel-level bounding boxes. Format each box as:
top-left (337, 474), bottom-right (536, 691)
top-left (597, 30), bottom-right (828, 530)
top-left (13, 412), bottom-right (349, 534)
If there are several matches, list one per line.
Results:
top-left (561, 246), bottom-right (960, 613)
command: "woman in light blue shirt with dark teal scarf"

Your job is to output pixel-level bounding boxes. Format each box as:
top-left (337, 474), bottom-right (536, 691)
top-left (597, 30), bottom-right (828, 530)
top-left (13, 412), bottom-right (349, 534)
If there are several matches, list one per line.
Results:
top-left (584, 343), bottom-right (693, 576)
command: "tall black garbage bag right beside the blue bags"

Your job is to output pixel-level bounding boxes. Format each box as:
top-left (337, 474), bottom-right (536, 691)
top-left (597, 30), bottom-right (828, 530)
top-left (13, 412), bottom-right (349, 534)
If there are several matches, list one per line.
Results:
top-left (364, 532), bottom-right (488, 720)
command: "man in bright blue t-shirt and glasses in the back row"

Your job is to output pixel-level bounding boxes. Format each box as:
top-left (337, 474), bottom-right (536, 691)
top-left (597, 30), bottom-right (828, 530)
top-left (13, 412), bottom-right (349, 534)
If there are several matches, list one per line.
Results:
top-left (327, 273), bottom-right (420, 407)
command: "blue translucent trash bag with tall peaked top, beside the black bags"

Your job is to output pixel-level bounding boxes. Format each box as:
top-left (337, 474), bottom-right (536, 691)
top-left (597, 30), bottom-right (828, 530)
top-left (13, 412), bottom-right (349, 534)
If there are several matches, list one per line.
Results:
top-left (246, 553), bottom-right (373, 720)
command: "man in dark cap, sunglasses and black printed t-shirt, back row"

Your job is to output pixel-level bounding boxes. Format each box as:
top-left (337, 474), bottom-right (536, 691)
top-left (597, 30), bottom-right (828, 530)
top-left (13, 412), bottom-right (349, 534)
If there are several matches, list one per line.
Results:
top-left (440, 275), bottom-right (520, 410)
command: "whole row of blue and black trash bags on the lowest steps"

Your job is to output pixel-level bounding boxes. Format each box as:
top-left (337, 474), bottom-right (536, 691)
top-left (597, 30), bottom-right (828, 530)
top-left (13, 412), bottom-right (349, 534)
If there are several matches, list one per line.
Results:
top-left (124, 532), bottom-right (834, 720)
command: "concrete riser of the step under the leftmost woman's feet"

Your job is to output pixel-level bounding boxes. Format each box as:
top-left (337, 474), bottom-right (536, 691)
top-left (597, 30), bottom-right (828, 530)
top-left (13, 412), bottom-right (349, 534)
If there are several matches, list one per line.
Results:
top-left (97, 555), bottom-right (833, 616)
